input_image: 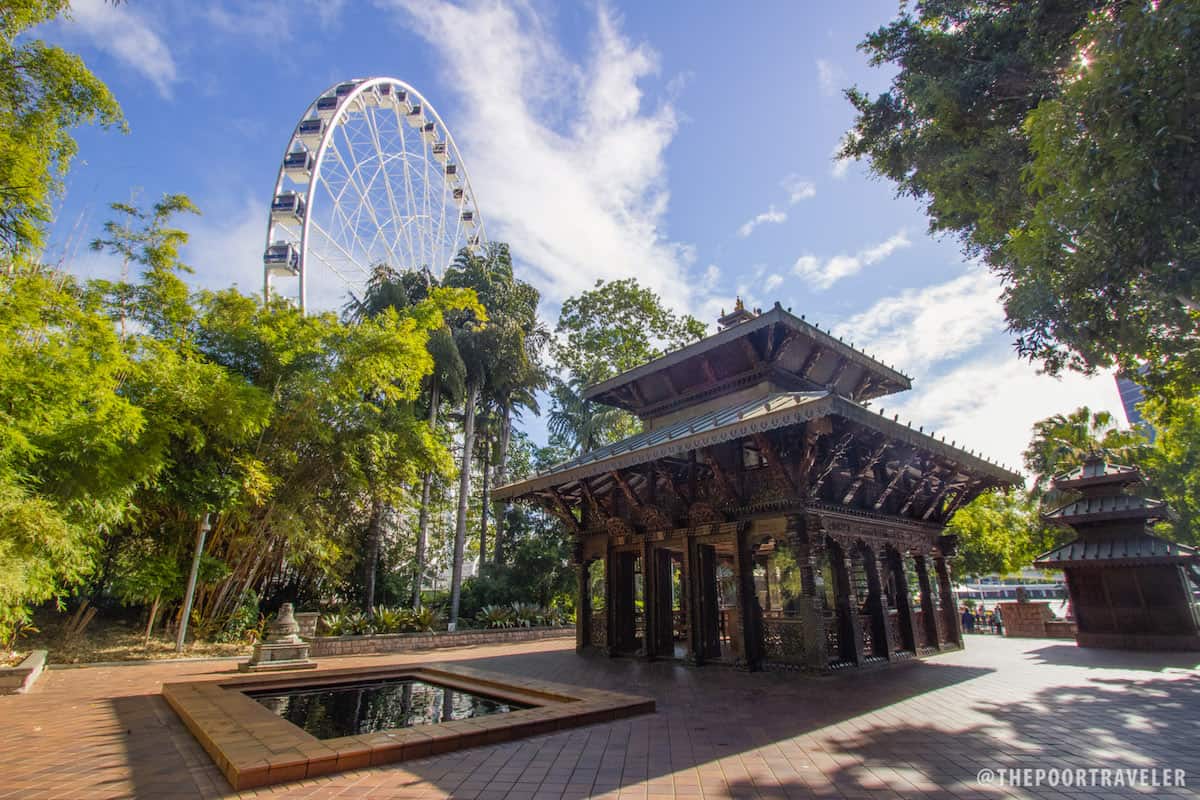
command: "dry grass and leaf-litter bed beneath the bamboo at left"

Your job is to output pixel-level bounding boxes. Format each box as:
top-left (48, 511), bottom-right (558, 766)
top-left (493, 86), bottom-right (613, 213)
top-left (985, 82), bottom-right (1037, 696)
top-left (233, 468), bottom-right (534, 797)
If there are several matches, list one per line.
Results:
top-left (20, 615), bottom-right (251, 664)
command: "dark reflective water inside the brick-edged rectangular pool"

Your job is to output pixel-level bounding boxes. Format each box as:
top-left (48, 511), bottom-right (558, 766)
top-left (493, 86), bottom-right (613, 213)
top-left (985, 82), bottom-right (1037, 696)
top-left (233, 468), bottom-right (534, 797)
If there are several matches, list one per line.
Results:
top-left (246, 678), bottom-right (530, 739)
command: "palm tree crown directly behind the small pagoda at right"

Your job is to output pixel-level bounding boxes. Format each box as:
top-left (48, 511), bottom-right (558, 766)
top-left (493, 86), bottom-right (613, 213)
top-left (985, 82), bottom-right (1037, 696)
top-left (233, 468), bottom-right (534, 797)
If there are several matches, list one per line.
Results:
top-left (1024, 405), bottom-right (1148, 497)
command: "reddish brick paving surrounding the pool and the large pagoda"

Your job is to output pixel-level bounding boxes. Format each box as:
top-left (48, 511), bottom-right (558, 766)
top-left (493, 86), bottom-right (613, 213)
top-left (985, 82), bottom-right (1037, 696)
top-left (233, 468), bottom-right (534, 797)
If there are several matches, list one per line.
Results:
top-left (0, 636), bottom-right (1200, 800)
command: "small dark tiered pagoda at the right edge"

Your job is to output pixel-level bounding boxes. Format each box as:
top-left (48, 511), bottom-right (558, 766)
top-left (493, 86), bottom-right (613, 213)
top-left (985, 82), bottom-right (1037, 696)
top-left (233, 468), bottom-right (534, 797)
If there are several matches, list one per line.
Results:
top-left (1034, 456), bottom-right (1200, 650)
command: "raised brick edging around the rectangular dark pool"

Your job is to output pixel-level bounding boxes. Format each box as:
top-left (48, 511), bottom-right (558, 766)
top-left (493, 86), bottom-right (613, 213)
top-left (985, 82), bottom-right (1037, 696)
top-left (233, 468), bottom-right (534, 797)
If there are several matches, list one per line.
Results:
top-left (162, 663), bottom-right (655, 790)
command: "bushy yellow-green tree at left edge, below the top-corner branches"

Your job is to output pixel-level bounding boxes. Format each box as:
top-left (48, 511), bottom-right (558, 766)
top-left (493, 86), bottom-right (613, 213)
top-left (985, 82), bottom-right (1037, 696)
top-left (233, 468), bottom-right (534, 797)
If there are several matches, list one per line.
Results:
top-left (0, 267), bottom-right (150, 640)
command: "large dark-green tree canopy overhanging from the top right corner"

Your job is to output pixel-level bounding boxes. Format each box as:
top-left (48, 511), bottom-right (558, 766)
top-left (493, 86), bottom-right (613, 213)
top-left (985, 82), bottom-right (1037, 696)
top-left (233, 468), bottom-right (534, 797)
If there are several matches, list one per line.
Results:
top-left (841, 0), bottom-right (1200, 386)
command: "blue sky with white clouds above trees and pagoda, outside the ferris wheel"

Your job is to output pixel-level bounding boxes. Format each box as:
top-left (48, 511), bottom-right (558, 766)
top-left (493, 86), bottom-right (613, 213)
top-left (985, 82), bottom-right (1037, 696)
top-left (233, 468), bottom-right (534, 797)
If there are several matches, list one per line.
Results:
top-left (40, 0), bottom-right (1123, 472)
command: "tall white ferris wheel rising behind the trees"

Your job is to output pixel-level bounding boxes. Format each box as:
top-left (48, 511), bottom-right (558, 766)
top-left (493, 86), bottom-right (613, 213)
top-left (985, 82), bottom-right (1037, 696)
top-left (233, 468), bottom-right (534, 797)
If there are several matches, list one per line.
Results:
top-left (263, 78), bottom-right (486, 311)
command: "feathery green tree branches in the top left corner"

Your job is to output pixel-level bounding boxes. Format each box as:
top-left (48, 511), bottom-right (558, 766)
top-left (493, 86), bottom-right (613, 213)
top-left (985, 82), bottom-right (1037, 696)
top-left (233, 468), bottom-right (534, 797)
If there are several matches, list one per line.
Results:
top-left (0, 0), bottom-right (124, 256)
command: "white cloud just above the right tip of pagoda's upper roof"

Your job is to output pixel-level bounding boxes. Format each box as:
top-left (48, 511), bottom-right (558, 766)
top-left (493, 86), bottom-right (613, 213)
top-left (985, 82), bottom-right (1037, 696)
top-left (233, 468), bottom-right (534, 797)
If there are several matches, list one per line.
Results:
top-left (833, 265), bottom-right (1004, 371)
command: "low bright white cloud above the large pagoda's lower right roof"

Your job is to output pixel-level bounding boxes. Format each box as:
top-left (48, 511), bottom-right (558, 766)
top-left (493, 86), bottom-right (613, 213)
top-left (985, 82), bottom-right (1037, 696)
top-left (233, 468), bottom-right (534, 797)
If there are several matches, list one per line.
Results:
top-left (875, 355), bottom-right (1123, 469)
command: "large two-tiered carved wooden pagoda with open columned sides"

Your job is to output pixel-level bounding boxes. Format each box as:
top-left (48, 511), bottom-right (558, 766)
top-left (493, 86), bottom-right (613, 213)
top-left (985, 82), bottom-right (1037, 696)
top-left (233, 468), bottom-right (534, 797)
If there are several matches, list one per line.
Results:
top-left (494, 302), bottom-right (1021, 670)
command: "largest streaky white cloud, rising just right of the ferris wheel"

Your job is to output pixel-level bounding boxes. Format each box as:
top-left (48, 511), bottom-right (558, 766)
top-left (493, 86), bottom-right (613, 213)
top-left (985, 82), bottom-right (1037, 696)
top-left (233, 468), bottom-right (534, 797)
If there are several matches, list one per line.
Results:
top-left (388, 0), bottom-right (698, 308)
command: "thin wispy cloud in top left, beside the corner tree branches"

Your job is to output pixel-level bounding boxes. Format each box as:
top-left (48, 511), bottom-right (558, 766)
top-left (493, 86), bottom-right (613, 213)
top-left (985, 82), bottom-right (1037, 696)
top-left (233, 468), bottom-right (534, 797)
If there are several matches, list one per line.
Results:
top-left (66, 0), bottom-right (179, 97)
